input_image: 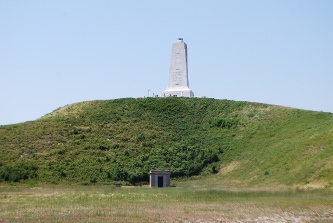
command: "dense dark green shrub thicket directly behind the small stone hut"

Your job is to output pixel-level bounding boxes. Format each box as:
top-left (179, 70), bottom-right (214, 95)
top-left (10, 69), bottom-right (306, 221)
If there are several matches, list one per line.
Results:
top-left (112, 145), bottom-right (221, 184)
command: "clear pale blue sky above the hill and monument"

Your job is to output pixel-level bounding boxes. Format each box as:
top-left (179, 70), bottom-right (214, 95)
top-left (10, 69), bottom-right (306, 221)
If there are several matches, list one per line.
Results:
top-left (0, 0), bottom-right (333, 125)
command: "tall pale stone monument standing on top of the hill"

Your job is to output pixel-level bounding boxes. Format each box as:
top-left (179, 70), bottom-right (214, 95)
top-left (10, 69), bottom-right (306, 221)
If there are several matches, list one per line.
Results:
top-left (162, 38), bottom-right (194, 97)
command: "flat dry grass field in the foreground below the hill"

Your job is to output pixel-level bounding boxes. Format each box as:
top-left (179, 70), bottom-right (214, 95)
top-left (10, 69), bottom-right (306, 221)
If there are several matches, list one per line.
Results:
top-left (0, 184), bottom-right (333, 222)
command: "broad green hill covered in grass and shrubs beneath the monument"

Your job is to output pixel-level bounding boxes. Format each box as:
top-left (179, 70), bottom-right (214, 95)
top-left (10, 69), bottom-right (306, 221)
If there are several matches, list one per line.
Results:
top-left (0, 98), bottom-right (333, 188)
